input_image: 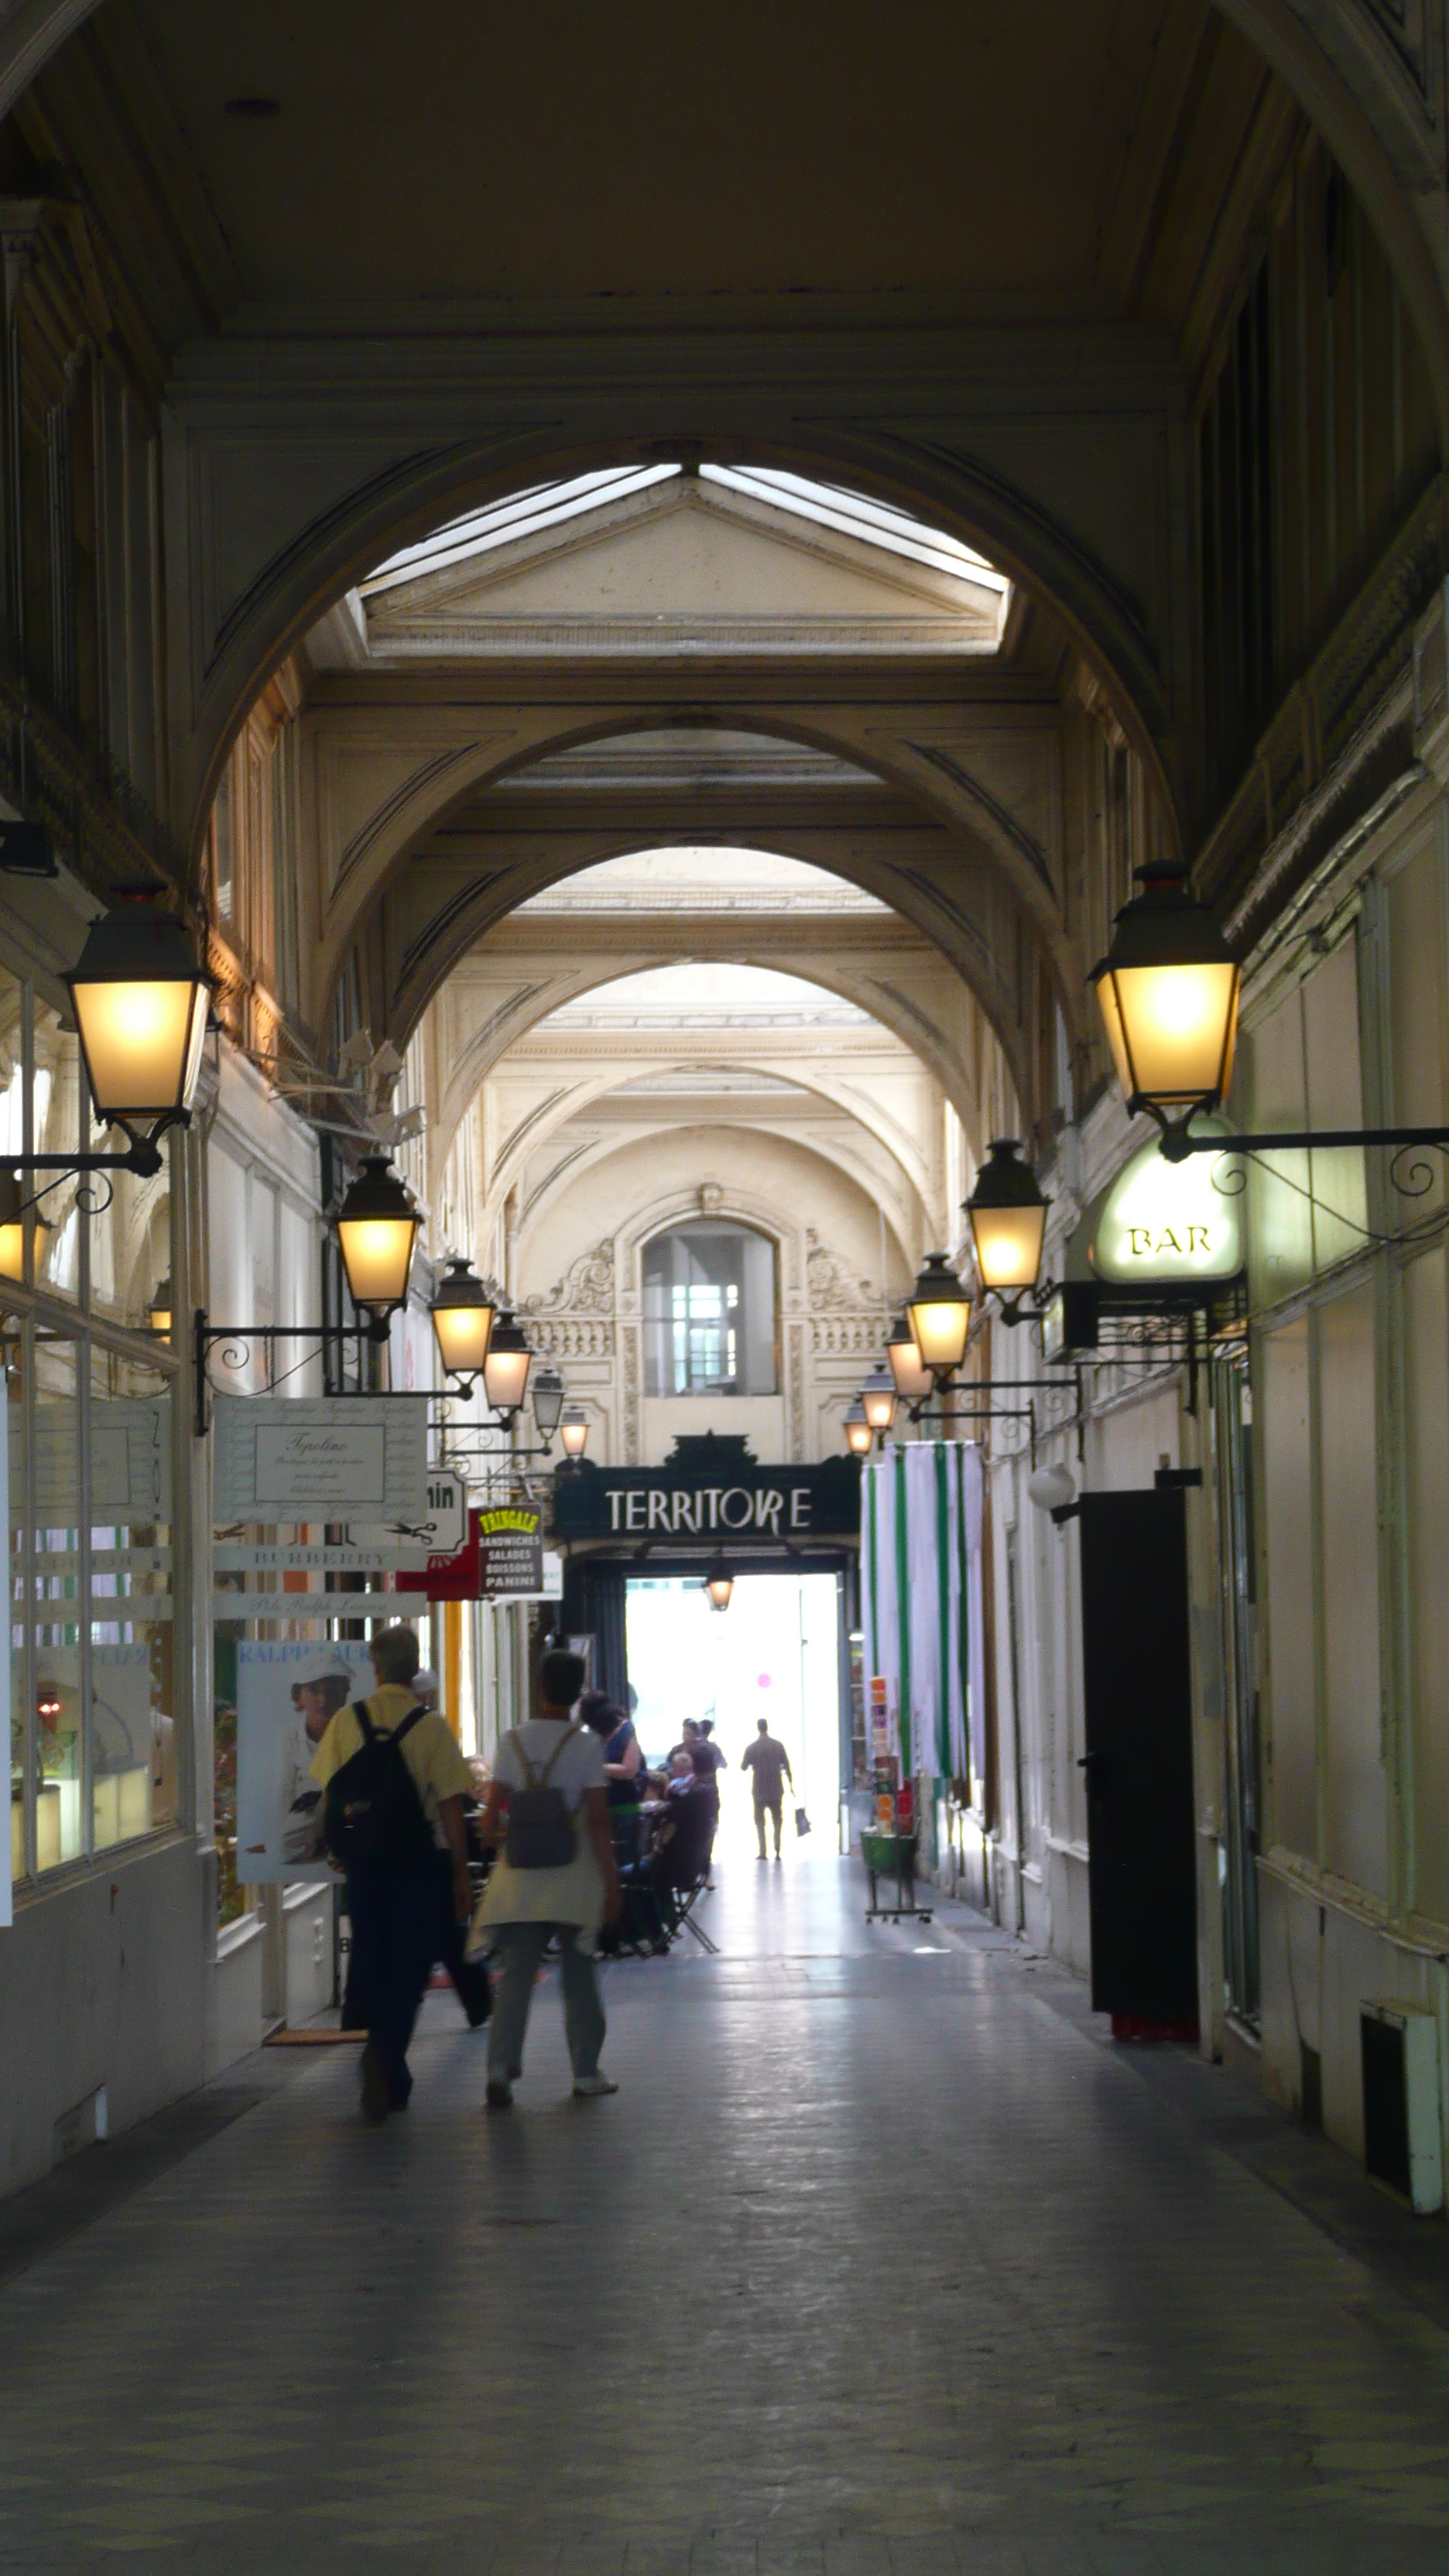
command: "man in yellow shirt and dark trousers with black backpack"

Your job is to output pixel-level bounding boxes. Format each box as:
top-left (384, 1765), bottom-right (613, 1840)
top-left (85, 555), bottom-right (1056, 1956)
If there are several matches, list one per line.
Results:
top-left (312, 1628), bottom-right (472, 2120)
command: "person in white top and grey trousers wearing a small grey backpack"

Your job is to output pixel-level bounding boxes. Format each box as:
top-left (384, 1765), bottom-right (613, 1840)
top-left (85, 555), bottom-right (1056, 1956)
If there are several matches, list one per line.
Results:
top-left (469, 1649), bottom-right (618, 2110)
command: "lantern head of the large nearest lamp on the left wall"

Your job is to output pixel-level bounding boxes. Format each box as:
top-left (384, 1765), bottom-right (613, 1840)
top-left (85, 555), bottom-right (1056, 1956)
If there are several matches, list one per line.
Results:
top-left (64, 902), bottom-right (211, 1125)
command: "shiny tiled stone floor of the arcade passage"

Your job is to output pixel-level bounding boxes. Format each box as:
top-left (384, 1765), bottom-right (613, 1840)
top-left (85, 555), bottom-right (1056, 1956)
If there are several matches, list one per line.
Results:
top-left (0, 1845), bottom-right (1449, 2576)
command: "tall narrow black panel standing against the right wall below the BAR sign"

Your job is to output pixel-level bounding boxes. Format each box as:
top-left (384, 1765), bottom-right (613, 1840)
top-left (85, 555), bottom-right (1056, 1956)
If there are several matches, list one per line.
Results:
top-left (1081, 1489), bottom-right (1197, 2033)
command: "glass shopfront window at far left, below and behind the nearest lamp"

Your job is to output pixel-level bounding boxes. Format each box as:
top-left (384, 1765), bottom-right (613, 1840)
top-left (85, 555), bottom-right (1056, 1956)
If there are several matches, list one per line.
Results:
top-left (0, 974), bottom-right (178, 1886)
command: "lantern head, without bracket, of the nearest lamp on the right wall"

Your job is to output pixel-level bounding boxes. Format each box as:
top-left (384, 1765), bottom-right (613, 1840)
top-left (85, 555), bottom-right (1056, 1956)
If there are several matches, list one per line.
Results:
top-left (1091, 865), bottom-right (1240, 1110)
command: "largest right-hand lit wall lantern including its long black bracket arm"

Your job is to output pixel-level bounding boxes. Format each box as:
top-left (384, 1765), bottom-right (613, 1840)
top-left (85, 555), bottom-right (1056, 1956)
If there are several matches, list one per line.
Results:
top-left (1091, 863), bottom-right (1449, 1162)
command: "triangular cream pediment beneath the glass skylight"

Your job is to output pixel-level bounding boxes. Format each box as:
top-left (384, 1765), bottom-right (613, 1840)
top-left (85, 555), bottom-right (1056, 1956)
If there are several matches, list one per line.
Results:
top-left (351, 477), bottom-right (1003, 662)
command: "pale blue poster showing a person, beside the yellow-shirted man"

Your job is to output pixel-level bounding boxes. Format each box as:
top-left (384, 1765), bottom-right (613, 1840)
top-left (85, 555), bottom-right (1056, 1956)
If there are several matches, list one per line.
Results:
top-left (237, 1641), bottom-right (376, 1888)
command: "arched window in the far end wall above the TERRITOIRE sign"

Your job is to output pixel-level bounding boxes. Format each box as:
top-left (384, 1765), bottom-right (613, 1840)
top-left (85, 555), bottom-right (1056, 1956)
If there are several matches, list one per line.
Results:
top-left (645, 1218), bottom-right (779, 1396)
